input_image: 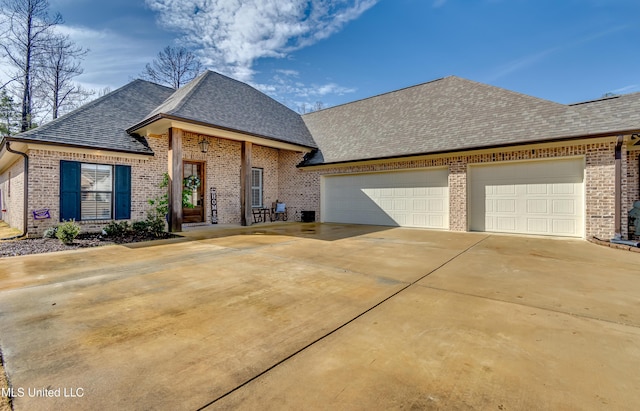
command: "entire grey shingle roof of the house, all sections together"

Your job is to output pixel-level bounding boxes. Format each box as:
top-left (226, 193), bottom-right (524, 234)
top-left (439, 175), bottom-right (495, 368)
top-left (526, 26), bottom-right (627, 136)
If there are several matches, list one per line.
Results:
top-left (10, 71), bottom-right (640, 165)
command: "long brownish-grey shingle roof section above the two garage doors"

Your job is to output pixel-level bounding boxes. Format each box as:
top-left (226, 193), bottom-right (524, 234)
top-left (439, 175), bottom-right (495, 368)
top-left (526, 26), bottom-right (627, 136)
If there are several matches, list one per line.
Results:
top-left (302, 76), bottom-right (640, 165)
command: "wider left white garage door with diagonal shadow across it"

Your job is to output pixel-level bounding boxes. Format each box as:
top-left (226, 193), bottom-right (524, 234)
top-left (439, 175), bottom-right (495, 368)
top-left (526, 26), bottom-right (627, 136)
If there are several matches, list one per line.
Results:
top-left (322, 169), bottom-right (449, 229)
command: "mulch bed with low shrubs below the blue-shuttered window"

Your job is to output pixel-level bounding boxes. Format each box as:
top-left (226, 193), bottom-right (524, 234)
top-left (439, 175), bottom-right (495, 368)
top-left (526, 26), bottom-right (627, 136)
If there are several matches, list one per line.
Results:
top-left (0, 233), bottom-right (176, 258)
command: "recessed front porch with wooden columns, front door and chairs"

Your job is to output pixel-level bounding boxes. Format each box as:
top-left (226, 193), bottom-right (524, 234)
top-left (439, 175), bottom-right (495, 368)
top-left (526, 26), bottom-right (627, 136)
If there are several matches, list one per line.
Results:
top-left (141, 126), bottom-right (318, 232)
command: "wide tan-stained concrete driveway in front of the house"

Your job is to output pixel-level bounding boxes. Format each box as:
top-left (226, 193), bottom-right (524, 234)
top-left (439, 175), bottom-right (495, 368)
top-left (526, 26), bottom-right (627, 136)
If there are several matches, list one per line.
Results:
top-left (0, 224), bottom-right (640, 410)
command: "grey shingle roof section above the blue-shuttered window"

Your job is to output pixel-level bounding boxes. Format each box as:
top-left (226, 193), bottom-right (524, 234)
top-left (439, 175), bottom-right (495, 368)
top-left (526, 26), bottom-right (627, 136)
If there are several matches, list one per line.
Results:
top-left (16, 80), bottom-right (174, 154)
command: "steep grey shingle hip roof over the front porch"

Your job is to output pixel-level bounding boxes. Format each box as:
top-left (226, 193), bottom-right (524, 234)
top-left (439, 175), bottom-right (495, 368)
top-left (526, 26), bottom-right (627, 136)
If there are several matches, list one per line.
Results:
top-left (134, 71), bottom-right (316, 148)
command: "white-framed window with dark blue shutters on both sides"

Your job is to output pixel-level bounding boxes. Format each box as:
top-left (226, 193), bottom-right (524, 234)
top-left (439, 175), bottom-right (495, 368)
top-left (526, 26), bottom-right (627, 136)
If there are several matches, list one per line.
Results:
top-left (60, 160), bottom-right (131, 221)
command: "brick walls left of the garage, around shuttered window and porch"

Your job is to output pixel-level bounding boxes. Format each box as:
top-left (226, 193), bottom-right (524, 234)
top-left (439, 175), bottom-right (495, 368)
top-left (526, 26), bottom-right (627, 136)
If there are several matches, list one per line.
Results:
top-left (15, 132), bottom-right (312, 236)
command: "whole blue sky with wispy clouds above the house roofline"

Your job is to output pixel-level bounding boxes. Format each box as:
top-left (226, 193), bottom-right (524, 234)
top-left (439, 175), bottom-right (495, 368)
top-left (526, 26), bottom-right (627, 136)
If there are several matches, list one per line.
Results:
top-left (45, 0), bottom-right (640, 108)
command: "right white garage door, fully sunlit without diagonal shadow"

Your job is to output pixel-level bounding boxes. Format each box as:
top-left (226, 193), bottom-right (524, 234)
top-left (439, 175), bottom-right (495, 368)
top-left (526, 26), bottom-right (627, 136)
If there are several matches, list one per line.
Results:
top-left (468, 159), bottom-right (584, 237)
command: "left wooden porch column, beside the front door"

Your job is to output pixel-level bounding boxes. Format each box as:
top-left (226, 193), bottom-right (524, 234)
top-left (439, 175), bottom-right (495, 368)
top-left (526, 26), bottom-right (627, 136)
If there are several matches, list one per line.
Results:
top-left (168, 128), bottom-right (183, 233)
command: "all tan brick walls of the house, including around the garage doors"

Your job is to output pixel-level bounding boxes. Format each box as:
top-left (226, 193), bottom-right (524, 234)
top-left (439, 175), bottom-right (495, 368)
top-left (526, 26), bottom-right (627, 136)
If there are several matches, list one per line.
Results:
top-left (11, 132), bottom-right (640, 238)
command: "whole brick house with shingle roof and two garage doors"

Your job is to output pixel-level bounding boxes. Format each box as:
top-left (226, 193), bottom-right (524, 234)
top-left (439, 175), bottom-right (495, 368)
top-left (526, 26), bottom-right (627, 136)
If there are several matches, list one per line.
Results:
top-left (0, 72), bottom-right (640, 239)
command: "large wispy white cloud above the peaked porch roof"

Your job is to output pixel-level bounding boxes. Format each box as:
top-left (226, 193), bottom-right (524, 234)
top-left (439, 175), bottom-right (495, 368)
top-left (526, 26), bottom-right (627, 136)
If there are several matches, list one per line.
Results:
top-left (146, 0), bottom-right (379, 81)
